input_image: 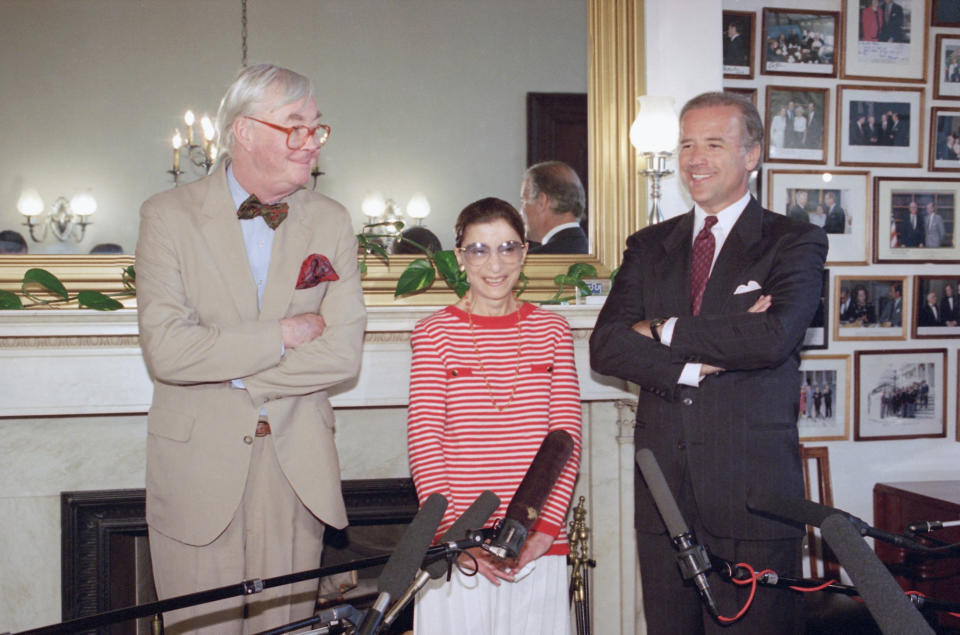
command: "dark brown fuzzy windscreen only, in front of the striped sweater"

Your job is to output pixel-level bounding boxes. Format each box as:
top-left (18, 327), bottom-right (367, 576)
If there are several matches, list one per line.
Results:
top-left (506, 430), bottom-right (573, 529)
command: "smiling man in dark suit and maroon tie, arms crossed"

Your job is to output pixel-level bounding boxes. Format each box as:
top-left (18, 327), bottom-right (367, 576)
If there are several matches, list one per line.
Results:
top-left (590, 93), bottom-right (827, 635)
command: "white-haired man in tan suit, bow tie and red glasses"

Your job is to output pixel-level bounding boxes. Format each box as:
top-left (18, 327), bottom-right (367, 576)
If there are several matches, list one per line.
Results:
top-left (131, 65), bottom-right (366, 633)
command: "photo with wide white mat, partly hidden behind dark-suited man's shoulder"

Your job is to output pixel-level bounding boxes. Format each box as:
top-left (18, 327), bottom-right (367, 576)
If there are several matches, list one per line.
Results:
top-left (767, 170), bottom-right (873, 265)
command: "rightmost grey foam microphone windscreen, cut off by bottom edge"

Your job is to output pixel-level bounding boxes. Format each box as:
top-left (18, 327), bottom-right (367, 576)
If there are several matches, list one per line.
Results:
top-left (820, 514), bottom-right (934, 635)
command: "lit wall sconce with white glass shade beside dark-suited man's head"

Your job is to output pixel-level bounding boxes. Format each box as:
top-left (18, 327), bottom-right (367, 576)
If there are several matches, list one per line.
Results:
top-left (630, 95), bottom-right (680, 225)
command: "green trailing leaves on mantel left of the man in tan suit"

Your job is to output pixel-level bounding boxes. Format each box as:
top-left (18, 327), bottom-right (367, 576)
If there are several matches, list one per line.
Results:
top-left (0, 265), bottom-right (136, 311)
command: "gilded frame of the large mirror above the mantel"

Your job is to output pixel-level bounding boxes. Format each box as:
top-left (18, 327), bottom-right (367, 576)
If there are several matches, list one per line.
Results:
top-left (0, 0), bottom-right (647, 307)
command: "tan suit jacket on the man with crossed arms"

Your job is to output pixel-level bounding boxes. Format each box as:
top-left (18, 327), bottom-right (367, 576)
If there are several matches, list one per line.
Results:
top-left (136, 164), bottom-right (366, 545)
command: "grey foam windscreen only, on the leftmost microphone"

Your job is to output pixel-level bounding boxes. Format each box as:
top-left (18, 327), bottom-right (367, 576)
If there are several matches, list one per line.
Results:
top-left (377, 494), bottom-right (447, 598)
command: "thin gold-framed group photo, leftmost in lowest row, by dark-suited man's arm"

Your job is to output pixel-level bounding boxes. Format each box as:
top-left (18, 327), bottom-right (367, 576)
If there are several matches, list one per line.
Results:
top-left (797, 355), bottom-right (850, 441)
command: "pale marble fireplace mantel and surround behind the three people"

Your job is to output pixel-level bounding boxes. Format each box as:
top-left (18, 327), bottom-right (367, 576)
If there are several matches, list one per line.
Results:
top-left (0, 306), bottom-right (643, 635)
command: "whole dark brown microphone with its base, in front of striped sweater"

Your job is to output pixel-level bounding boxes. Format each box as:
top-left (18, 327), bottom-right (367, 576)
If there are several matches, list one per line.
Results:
top-left (483, 430), bottom-right (573, 559)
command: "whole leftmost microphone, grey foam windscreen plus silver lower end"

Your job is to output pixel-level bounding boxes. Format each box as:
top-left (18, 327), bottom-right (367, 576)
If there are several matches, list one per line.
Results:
top-left (357, 494), bottom-right (447, 635)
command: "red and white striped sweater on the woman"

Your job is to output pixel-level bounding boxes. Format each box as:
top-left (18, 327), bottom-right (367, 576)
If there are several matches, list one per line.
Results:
top-left (407, 303), bottom-right (581, 555)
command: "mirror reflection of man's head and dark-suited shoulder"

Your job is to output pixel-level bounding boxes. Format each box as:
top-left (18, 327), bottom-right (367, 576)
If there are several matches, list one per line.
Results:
top-left (520, 161), bottom-right (590, 254)
